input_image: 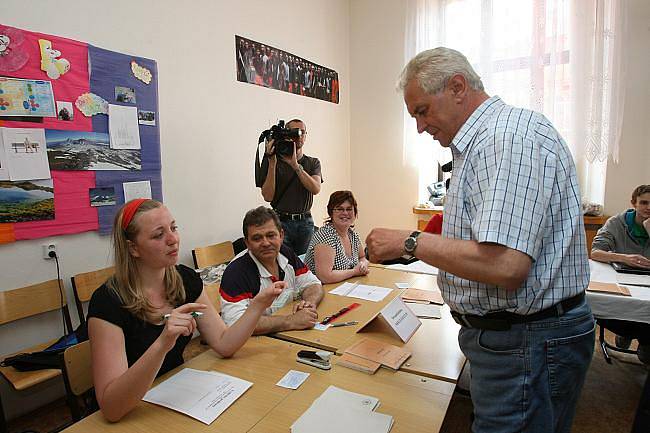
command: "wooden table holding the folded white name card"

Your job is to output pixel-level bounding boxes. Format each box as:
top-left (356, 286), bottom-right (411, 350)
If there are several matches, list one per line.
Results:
top-left (275, 266), bottom-right (465, 383)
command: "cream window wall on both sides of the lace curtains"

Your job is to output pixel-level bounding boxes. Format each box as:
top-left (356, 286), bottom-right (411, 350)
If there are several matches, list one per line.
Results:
top-left (350, 0), bottom-right (650, 235)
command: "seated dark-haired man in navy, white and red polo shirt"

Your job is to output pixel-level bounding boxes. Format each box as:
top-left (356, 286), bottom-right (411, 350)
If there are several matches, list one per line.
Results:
top-left (220, 206), bottom-right (323, 334)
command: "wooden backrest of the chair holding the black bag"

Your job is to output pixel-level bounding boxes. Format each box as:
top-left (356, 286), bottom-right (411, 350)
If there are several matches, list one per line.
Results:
top-left (0, 280), bottom-right (72, 330)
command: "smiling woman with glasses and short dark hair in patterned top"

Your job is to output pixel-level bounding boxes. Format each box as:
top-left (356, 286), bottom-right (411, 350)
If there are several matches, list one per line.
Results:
top-left (305, 191), bottom-right (368, 284)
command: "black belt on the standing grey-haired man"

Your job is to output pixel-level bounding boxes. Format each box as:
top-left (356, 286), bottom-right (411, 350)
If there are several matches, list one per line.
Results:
top-left (451, 292), bottom-right (585, 331)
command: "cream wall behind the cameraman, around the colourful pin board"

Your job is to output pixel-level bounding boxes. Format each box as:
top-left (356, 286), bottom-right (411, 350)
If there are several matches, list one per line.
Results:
top-left (0, 0), bottom-right (351, 416)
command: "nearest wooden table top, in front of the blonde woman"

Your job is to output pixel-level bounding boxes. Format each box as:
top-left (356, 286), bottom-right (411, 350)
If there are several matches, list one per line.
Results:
top-left (64, 337), bottom-right (453, 433)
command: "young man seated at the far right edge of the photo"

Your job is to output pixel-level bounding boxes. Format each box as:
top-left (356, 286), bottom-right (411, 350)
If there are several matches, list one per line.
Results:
top-left (591, 185), bottom-right (650, 364)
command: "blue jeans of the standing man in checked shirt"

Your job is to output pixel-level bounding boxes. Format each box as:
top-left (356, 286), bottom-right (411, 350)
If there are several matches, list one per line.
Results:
top-left (458, 301), bottom-right (595, 433)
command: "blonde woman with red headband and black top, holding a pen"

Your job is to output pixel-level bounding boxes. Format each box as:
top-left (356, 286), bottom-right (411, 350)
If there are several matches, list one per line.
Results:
top-left (88, 199), bottom-right (284, 421)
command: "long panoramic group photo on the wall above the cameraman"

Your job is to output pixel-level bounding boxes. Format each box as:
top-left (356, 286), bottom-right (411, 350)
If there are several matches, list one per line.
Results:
top-left (235, 35), bottom-right (339, 104)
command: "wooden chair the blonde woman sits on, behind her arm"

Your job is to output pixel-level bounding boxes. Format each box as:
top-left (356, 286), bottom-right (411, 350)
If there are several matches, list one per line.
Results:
top-left (61, 341), bottom-right (98, 422)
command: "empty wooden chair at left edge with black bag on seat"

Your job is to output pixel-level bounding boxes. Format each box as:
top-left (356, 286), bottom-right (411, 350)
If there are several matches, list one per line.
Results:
top-left (0, 280), bottom-right (72, 433)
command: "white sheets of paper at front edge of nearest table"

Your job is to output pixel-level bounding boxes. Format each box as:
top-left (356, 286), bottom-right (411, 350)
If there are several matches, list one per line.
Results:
top-left (291, 386), bottom-right (393, 433)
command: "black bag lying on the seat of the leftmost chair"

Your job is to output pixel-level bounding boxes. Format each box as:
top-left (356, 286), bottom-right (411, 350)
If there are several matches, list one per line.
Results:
top-left (0, 323), bottom-right (88, 371)
